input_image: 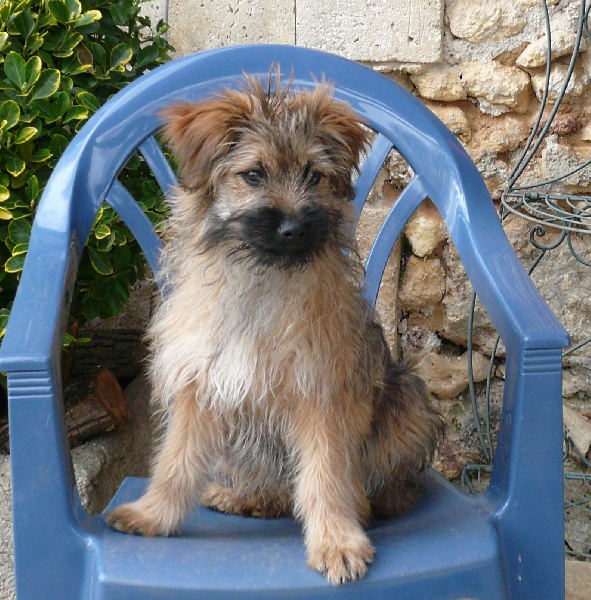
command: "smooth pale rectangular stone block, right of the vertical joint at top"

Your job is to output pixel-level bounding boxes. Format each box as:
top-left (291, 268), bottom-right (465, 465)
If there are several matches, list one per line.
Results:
top-left (296, 0), bottom-right (443, 63)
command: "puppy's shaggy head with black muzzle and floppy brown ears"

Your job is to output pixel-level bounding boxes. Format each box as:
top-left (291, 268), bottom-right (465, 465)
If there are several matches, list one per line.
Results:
top-left (163, 70), bottom-right (371, 268)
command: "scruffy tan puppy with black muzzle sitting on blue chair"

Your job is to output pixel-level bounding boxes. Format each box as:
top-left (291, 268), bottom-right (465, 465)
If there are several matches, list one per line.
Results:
top-left (107, 70), bottom-right (442, 584)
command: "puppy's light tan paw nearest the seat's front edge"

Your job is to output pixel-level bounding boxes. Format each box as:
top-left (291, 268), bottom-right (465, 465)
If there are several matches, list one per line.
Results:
top-left (308, 532), bottom-right (375, 585)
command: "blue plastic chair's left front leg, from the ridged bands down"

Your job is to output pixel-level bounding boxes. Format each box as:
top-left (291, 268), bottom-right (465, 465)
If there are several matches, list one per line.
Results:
top-left (8, 372), bottom-right (89, 599)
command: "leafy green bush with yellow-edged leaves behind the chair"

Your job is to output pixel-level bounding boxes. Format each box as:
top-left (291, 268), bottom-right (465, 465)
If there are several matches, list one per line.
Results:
top-left (0, 0), bottom-right (172, 336)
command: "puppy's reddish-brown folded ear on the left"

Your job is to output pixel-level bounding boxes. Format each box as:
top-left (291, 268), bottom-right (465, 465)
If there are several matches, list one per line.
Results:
top-left (160, 92), bottom-right (252, 193)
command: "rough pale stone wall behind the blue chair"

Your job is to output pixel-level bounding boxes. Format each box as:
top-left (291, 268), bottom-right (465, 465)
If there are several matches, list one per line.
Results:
top-left (140, 0), bottom-right (591, 477)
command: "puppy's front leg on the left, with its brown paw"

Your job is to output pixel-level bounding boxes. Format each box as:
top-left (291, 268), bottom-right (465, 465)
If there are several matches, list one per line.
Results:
top-left (107, 387), bottom-right (219, 536)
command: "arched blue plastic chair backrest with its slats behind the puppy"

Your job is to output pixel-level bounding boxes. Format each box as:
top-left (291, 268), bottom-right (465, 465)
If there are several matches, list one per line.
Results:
top-left (6, 46), bottom-right (568, 360)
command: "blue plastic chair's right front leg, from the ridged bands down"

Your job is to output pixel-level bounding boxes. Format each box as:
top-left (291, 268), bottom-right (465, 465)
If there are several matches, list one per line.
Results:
top-left (490, 349), bottom-right (565, 600)
